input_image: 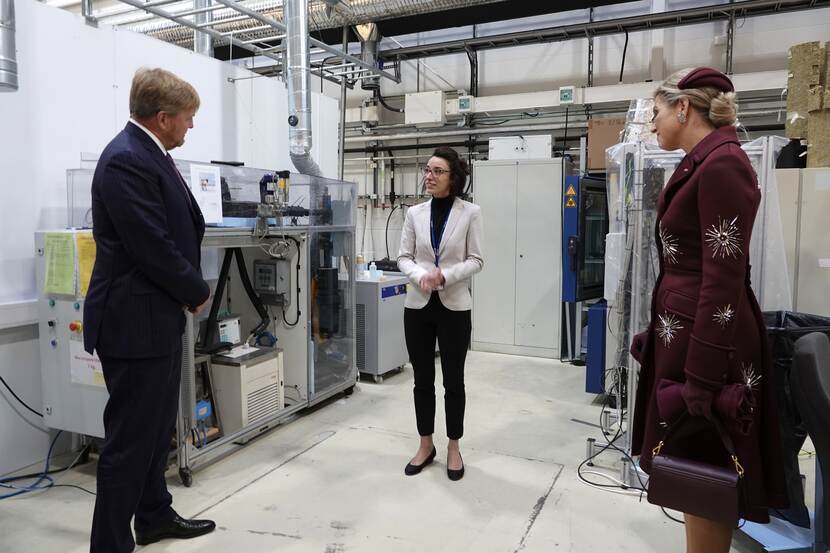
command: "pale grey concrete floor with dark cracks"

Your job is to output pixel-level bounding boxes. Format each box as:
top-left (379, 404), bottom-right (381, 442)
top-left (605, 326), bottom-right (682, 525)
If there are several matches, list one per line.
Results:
top-left (0, 352), bottom-right (796, 553)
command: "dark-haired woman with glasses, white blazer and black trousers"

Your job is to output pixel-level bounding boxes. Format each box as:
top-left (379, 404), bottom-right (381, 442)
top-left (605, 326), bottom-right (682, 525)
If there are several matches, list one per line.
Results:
top-left (398, 147), bottom-right (484, 480)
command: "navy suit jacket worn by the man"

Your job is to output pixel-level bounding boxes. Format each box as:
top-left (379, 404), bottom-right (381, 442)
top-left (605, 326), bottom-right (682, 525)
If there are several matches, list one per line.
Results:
top-left (84, 123), bottom-right (210, 359)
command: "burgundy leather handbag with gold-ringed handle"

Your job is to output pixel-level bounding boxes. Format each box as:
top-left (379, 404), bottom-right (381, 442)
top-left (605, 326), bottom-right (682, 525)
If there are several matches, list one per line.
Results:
top-left (648, 417), bottom-right (744, 525)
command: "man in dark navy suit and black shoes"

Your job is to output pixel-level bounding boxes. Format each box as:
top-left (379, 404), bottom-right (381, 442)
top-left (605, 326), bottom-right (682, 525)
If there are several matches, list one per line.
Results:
top-left (84, 69), bottom-right (215, 553)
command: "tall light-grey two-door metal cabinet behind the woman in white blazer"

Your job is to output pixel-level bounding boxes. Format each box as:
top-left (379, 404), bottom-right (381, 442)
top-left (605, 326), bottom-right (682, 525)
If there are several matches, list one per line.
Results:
top-left (472, 159), bottom-right (562, 358)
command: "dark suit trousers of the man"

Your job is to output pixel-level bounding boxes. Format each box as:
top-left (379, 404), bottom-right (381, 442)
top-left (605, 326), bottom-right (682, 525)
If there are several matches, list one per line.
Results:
top-left (90, 351), bottom-right (182, 553)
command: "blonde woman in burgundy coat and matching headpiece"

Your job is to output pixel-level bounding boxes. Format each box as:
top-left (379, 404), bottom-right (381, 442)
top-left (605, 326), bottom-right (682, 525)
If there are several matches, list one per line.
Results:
top-left (632, 68), bottom-right (786, 553)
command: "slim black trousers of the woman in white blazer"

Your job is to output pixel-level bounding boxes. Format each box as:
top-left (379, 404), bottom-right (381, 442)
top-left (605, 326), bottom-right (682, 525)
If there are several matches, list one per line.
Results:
top-left (404, 292), bottom-right (472, 440)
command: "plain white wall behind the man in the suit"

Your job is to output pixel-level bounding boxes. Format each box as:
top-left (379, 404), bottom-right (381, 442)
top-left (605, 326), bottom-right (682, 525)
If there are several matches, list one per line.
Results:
top-left (0, 0), bottom-right (339, 474)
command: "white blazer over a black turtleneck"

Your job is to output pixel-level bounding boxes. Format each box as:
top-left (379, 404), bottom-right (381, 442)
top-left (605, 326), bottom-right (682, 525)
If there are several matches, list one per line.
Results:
top-left (398, 198), bottom-right (484, 311)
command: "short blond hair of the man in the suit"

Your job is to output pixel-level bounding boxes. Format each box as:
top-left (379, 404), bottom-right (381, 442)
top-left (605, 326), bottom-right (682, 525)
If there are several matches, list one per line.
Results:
top-left (130, 67), bottom-right (200, 119)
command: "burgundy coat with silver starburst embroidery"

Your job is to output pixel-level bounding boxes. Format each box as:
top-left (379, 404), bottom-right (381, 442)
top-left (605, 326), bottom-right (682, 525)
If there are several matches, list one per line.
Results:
top-left (632, 127), bottom-right (786, 522)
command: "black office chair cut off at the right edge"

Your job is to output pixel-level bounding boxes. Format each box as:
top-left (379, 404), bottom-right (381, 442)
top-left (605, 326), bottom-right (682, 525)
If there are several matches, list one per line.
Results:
top-left (790, 332), bottom-right (830, 544)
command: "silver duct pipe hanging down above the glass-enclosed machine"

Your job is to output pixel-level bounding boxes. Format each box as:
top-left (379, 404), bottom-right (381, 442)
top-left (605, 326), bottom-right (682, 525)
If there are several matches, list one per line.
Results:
top-left (284, 0), bottom-right (323, 177)
